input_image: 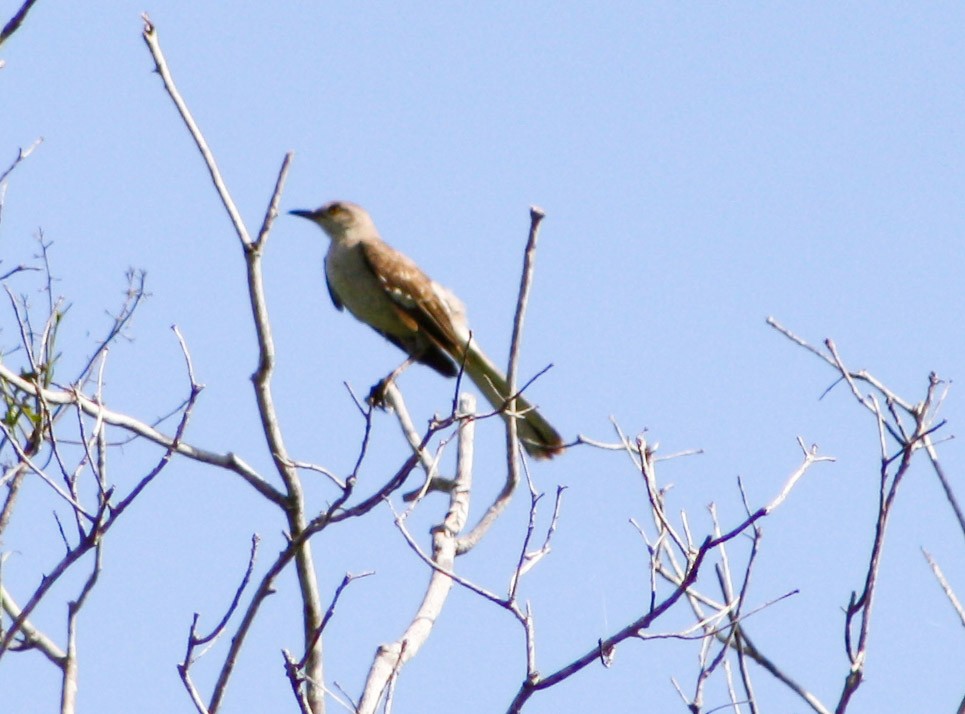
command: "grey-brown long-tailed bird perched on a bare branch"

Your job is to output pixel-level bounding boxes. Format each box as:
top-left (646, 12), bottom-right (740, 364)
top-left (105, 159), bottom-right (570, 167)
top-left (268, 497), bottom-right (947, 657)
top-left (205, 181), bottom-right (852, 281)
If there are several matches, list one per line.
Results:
top-left (291, 201), bottom-right (563, 458)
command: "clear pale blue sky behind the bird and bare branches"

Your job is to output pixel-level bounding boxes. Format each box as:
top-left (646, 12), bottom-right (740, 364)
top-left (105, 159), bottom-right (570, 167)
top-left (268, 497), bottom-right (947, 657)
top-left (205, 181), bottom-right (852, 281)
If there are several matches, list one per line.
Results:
top-left (0, 0), bottom-right (965, 714)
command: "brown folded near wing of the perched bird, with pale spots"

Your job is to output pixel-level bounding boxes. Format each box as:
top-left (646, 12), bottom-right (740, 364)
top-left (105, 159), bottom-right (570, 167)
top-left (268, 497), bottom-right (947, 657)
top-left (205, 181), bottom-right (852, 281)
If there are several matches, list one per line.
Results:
top-left (362, 241), bottom-right (463, 356)
